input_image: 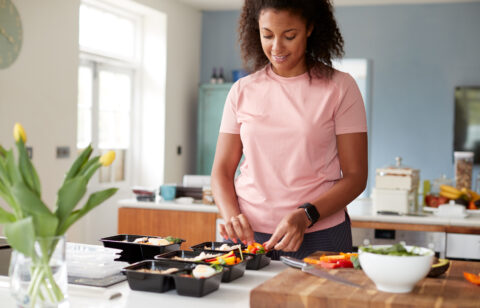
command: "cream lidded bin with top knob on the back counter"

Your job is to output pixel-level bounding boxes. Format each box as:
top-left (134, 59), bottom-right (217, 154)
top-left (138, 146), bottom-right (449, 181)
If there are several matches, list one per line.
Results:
top-left (372, 157), bottom-right (420, 213)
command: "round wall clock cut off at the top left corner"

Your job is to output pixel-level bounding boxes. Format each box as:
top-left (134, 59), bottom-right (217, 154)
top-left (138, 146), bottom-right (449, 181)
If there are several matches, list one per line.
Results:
top-left (0, 0), bottom-right (23, 69)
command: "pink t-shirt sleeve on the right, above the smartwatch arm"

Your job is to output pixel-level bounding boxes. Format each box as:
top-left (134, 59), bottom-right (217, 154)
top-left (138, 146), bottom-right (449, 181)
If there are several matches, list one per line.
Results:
top-left (334, 74), bottom-right (367, 135)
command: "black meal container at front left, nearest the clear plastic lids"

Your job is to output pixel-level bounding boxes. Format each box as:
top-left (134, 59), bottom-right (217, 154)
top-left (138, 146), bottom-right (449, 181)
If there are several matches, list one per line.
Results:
top-left (122, 260), bottom-right (193, 293)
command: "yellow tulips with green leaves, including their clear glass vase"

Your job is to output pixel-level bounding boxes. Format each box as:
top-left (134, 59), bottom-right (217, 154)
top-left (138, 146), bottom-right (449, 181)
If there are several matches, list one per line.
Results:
top-left (0, 123), bottom-right (117, 307)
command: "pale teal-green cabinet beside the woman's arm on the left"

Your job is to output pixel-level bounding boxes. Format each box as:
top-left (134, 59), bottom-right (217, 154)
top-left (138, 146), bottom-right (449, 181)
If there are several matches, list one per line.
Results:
top-left (197, 83), bottom-right (232, 175)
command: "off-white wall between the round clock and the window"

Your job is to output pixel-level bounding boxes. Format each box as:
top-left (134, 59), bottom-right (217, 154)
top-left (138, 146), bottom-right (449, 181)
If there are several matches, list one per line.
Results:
top-left (0, 0), bottom-right (79, 224)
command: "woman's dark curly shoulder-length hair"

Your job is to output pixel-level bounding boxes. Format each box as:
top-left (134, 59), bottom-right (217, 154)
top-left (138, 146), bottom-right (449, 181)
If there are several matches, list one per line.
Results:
top-left (238, 0), bottom-right (344, 78)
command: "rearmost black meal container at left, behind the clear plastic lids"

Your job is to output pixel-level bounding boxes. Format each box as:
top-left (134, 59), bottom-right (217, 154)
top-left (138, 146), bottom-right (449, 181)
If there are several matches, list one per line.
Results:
top-left (100, 234), bottom-right (185, 263)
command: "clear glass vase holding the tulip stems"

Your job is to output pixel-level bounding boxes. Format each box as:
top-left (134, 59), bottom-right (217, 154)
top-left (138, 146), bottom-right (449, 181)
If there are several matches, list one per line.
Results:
top-left (9, 236), bottom-right (68, 308)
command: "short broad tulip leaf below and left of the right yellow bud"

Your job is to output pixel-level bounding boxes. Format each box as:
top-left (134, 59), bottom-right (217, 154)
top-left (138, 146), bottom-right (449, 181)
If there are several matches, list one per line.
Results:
top-left (55, 176), bottom-right (88, 224)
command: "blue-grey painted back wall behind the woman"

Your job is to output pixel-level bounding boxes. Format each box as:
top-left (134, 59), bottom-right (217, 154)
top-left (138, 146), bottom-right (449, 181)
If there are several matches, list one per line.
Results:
top-left (201, 3), bottom-right (480, 192)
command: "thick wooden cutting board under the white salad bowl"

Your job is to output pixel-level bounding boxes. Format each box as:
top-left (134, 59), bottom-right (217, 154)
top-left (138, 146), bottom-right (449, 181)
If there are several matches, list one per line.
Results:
top-left (250, 252), bottom-right (480, 308)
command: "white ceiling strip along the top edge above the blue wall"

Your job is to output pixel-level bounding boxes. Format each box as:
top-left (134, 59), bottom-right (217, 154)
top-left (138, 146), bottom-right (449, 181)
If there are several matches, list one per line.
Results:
top-left (179, 0), bottom-right (480, 11)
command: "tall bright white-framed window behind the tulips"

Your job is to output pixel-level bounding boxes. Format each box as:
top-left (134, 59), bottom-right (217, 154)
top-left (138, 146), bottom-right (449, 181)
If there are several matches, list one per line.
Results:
top-left (77, 1), bottom-right (140, 183)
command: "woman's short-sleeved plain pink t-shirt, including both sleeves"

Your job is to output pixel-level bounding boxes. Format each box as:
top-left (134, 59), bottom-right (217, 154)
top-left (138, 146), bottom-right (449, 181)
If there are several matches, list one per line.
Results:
top-left (220, 65), bottom-right (367, 233)
